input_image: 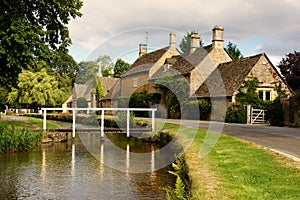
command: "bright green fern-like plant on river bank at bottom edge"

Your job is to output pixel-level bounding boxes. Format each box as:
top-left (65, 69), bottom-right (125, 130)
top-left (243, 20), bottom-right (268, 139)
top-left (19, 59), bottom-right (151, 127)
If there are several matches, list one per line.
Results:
top-left (164, 156), bottom-right (189, 200)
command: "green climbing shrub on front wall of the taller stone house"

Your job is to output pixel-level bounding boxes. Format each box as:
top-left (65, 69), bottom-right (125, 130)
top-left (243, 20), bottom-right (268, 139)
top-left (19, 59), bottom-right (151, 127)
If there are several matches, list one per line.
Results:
top-left (155, 74), bottom-right (189, 118)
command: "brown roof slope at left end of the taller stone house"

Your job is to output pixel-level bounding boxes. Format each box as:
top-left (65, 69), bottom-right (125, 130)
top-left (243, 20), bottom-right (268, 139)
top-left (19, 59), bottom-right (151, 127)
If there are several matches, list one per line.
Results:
top-left (121, 47), bottom-right (168, 77)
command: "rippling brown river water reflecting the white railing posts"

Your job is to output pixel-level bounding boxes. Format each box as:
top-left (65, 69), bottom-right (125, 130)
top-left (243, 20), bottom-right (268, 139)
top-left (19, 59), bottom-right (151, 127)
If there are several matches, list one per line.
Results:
top-left (0, 133), bottom-right (175, 200)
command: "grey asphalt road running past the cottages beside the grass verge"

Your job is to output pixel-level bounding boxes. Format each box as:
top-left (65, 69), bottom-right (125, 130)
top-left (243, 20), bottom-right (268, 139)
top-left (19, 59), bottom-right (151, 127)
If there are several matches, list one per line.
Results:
top-left (162, 119), bottom-right (300, 161)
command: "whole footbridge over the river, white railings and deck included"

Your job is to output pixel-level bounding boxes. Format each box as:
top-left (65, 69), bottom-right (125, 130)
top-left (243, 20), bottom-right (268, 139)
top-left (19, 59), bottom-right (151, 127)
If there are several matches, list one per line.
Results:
top-left (42, 108), bottom-right (157, 137)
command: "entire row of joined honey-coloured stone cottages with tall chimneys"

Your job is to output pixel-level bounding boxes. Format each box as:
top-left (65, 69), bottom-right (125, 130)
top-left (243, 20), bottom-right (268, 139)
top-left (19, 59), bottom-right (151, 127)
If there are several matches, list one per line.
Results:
top-left (101, 26), bottom-right (293, 122)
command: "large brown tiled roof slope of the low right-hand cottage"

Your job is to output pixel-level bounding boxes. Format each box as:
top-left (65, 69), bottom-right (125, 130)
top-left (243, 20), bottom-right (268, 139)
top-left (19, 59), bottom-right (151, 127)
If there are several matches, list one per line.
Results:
top-left (195, 54), bottom-right (264, 97)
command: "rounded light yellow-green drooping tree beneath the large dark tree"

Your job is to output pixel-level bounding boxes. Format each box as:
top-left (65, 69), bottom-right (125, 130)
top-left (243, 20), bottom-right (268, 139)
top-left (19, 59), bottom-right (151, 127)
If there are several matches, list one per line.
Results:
top-left (7, 69), bottom-right (62, 108)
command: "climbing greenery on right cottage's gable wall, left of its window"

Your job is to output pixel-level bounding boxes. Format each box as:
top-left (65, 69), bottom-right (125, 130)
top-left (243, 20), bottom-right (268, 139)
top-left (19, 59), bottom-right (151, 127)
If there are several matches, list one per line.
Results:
top-left (236, 78), bottom-right (264, 108)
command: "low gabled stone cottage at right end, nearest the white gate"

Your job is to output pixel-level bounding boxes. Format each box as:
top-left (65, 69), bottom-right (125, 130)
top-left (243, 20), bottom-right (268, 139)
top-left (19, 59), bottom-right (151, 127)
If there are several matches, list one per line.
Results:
top-left (195, 53), bottom-right (293, 105)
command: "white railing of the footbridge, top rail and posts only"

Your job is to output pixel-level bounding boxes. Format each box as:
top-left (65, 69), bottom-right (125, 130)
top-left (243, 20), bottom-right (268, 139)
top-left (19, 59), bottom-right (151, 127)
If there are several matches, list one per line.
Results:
top-left (41, 108), bottom-right (157, 137)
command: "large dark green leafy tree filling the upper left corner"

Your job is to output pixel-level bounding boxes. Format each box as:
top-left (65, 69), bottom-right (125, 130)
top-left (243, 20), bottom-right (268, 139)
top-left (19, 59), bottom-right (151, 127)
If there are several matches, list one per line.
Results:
top-left (0, 0), bottom-right (83, 88)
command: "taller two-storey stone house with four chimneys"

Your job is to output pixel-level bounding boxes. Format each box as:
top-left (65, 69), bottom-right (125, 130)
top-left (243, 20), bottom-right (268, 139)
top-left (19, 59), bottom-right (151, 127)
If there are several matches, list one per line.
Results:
top-left (120, 26), bottom-right (232, 97)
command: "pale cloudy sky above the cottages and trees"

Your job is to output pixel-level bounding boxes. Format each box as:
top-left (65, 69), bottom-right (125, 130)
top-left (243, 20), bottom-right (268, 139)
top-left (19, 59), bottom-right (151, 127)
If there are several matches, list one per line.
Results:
top-left (68, 0), bottom-right (300, 65)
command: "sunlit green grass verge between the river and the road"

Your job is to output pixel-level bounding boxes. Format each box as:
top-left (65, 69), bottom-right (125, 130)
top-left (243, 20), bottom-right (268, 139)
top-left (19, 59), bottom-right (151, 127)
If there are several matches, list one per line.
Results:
top-left (164, 124), bottom-right (300, 199)
